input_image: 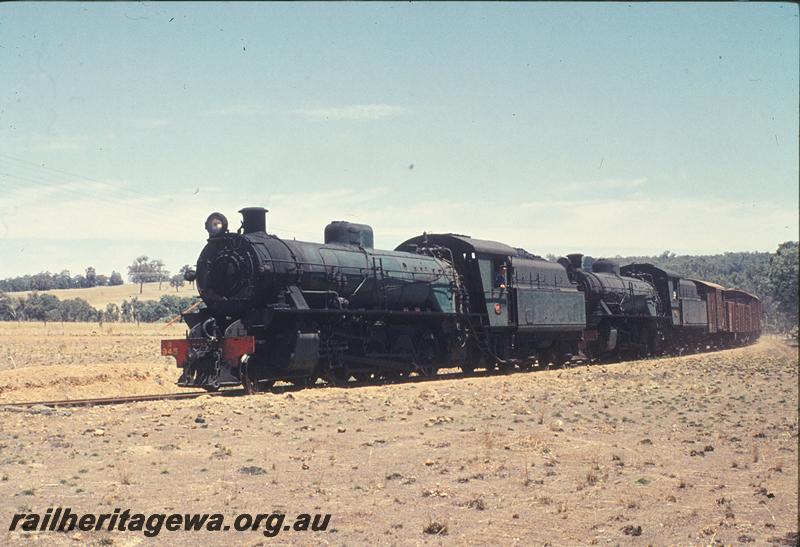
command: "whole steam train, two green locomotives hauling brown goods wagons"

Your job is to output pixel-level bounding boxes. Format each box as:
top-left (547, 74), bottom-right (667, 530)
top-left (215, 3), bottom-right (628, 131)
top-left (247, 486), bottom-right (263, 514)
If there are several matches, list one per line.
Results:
top-left (161, 207), bottom-right (761, 393)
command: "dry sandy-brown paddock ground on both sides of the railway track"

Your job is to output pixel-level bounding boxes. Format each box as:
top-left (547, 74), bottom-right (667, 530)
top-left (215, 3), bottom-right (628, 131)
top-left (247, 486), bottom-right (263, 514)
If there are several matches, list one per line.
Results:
top-left (0, 327), bottom-right (798, 545)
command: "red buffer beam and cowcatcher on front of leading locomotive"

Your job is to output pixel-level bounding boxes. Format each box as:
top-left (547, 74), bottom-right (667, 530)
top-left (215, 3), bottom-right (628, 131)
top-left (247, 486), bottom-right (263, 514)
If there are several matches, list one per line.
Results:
top-left (161, 336), bottom-right (256, 390)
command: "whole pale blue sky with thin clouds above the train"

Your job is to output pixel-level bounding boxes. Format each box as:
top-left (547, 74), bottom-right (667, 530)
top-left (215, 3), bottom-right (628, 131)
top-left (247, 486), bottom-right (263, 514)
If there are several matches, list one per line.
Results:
top-left (0, 3), bottom-right (800, 277)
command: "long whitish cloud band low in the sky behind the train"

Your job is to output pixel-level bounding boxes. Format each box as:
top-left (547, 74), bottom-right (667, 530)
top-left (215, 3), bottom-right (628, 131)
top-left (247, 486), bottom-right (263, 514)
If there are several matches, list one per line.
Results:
top-left (0, 181), bottom-right (798, 278)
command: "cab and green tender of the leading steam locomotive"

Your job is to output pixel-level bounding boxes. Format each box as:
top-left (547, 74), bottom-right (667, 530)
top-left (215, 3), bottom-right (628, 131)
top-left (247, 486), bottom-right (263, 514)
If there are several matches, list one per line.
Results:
top-left (397, 234), bottom-right (586, 370)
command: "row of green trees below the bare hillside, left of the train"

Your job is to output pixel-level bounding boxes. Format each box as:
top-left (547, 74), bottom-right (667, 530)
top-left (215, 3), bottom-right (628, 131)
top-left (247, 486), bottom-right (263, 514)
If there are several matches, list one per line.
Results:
top-left (0, 292), bottom-right (198, 323)
